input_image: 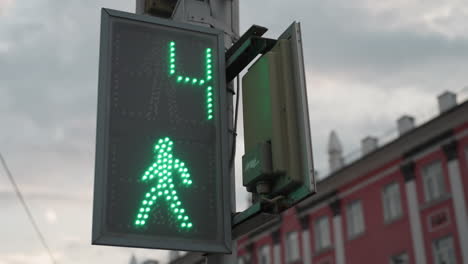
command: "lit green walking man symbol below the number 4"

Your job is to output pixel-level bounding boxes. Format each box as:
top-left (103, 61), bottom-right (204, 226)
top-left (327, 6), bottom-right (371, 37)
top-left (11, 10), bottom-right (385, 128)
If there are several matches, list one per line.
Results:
top-left (135, 137), bottom-right (193, 230)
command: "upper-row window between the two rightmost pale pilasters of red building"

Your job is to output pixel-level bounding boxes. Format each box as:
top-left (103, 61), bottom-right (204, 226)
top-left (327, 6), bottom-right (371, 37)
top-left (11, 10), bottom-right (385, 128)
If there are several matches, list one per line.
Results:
top-left (422, 161), bottom-right (445, 202)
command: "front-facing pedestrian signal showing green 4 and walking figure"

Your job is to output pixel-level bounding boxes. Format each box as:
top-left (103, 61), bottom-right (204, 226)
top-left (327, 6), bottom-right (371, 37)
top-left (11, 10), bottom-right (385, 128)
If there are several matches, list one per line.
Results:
top-left (92, 9), bottom-right (231, 253)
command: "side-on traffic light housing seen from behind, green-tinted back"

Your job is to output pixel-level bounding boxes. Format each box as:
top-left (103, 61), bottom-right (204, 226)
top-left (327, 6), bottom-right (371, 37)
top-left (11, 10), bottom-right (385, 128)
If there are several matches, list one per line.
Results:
top-left (242, 23), bottom-right (315, 204)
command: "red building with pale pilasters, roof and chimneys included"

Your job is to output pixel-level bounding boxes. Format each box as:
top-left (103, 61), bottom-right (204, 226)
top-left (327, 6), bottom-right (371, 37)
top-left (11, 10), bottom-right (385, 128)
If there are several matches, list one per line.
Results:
top-left (238, 93), bottom-right (468, 264)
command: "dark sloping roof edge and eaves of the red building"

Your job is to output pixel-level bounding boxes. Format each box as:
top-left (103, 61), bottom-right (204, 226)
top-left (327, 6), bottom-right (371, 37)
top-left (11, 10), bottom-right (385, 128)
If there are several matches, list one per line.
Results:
top-left (297, 98), bottom-right (468, 212)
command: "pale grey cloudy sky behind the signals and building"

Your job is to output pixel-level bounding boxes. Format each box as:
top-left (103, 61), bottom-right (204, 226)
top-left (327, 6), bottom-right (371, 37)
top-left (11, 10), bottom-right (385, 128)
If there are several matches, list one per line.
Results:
top-left (0, 0), bottom-right (468, 264)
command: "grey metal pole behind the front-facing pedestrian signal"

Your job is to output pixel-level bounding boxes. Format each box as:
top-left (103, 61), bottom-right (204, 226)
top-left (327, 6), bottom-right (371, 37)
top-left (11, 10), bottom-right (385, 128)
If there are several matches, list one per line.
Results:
top-left (136, 0), bottom-right (239, 264)
